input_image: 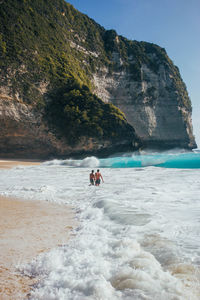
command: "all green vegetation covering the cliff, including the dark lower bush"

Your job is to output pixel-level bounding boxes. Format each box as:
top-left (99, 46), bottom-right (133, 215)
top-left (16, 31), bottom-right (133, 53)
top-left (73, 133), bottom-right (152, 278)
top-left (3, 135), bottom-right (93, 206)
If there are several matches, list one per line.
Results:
top-left (0, 0), bottom-right (191, 142)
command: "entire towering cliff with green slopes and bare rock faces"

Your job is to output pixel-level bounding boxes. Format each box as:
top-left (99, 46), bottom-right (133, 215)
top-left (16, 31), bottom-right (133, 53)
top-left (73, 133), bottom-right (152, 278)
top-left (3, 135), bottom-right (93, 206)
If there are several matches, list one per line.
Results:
top-left (0, 0), bottom-right (196, 159)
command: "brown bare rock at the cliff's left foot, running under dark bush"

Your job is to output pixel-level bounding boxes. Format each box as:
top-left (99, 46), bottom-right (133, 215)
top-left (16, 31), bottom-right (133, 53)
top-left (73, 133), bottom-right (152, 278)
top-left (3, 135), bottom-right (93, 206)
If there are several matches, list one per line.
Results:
top-left (0, 93), bottom-right (137, 159)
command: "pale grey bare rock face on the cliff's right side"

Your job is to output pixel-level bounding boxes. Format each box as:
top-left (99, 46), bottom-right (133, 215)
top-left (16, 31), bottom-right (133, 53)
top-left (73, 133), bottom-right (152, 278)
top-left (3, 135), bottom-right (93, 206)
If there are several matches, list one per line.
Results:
top-left (93, 61), bottom-right (196, 149)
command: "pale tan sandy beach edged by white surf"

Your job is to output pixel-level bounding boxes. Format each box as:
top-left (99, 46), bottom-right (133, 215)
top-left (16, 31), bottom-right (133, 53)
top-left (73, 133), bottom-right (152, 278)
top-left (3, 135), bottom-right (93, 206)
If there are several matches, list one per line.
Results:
top-left (0, 161), bottom-right (75, 300)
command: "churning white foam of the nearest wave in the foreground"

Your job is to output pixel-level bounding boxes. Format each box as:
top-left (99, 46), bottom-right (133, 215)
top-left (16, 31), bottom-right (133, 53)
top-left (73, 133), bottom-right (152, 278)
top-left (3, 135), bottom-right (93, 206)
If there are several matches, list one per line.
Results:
top-left (21, 237), bottom-right (198, 300)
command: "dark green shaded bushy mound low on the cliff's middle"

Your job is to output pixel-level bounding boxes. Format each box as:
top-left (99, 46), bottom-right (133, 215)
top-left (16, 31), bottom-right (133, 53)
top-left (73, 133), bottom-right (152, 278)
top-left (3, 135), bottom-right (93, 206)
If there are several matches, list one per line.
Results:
top-left (46, 79), bottom-right (135, 144)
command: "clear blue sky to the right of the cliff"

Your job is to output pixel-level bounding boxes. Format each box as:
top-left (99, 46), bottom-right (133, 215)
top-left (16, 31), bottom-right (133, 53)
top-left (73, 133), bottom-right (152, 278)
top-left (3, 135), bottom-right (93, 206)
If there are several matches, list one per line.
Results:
top-left (67, 0), bottom-right (200, 148)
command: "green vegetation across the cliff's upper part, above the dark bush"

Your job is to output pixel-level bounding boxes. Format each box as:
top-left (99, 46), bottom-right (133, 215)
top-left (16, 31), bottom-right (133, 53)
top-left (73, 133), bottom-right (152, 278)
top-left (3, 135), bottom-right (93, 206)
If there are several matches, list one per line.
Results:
top-left (0, 0), bottom-right (191, 108)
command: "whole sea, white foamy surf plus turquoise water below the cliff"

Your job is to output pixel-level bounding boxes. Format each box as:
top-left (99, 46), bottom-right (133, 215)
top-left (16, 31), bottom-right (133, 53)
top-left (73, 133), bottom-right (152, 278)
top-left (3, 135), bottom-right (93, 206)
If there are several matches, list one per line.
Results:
top-left (0, 150), bottom-right (200, 300)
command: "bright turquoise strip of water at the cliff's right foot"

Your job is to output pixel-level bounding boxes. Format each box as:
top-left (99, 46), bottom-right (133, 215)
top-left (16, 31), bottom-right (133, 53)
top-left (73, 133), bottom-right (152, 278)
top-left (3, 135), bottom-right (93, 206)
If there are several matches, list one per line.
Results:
top-left (99, 152), bottom-right (200, 169)
